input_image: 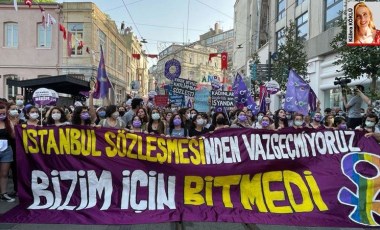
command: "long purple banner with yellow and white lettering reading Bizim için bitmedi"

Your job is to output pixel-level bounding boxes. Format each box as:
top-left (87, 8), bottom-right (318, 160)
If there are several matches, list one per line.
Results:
top-left (0, 126), bottom-right (380, 227)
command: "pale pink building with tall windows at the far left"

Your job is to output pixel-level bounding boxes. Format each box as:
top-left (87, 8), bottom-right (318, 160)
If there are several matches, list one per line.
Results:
top-left (0, 3), bottom-right (63, 99)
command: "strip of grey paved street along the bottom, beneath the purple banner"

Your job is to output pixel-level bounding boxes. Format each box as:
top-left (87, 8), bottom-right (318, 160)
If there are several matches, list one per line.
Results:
top-left (0, 180), bottom-right (368, 230)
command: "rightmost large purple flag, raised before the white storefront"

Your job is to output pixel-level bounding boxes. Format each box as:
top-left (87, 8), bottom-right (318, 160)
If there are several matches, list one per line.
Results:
top-left (284, 69), bottom-right (310, 115)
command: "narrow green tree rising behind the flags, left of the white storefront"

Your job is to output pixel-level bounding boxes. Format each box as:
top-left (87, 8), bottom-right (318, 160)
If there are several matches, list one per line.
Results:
top-left (272, 21), bottom-right (307, 89)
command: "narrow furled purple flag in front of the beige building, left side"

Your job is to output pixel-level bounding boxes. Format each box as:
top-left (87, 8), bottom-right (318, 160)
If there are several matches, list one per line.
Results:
top-left (94, 46), bottom-right (111, 99)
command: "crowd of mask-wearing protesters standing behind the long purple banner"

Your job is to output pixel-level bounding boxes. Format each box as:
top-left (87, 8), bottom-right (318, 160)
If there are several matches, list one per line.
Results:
top-left (0, 87), bottom-right (380, 202)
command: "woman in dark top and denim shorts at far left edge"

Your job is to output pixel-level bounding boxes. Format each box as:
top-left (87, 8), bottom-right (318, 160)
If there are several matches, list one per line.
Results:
top-left (0, 103), bottom-right (15, 202)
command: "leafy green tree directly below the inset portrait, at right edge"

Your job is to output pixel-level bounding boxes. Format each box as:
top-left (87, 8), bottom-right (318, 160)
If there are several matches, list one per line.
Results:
top-left (330, 13), bottom-right (380, 99)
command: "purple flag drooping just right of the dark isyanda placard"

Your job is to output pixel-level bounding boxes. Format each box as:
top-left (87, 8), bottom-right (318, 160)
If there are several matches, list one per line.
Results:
top-left (232, 73), bottom-right (259, 114)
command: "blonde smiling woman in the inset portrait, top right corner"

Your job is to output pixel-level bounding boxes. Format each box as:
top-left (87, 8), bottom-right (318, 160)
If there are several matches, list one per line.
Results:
top-left (354, 2), bottom-right (380, 45)
